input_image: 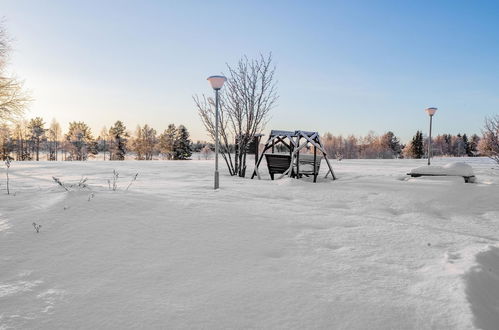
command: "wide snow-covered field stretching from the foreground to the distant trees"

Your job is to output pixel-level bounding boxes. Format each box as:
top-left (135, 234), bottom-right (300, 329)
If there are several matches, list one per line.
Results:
top-left (0, 158), bottom-right (499, 329)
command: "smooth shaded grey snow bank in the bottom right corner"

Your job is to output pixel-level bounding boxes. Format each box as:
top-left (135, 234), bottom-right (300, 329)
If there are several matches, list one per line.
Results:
top-left (465, 247), bottom-right (499, 330)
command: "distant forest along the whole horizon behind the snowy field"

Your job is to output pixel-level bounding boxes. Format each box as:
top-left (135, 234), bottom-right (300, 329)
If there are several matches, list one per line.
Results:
top-left (0, 117), bottom-right (488, 161)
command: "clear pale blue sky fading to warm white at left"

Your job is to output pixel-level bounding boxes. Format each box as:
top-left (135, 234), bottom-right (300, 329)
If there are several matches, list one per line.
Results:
top-left (0, 0), bottom-right (499, 141)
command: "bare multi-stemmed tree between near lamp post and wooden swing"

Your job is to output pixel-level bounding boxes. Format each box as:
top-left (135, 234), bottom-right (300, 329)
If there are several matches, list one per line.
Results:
top-left (194, 54), bottom-right (278, 177)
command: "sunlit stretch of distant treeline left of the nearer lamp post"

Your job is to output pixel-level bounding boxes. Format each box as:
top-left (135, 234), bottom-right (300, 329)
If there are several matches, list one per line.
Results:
top-left (0, 117), bottom-right (199, 161)
